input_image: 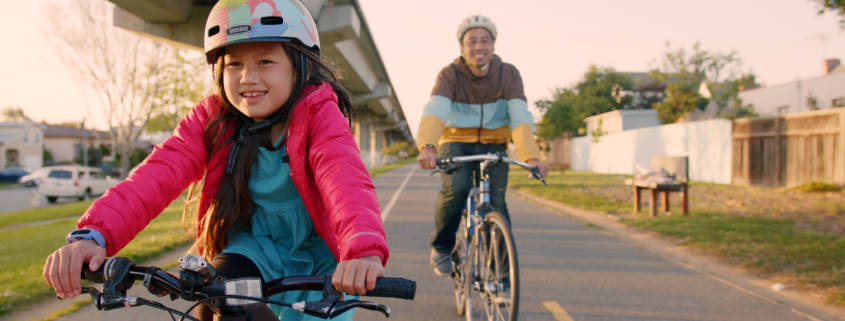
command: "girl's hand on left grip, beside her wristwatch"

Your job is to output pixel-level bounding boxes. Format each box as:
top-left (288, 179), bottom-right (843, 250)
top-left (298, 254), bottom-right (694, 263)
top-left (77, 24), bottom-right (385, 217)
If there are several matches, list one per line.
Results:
top-left (43, 240), bottom-right (106, 299)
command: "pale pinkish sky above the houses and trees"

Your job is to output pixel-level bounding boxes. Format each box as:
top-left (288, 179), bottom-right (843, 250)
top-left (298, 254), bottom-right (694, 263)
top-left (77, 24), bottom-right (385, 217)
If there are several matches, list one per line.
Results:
top-left (0, 0), bottom-right (845, 134)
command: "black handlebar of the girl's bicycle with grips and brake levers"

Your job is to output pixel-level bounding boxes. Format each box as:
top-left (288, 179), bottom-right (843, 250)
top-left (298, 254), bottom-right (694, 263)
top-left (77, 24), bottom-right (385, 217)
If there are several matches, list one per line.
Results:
top-left (81, 255), bottom-right (416, 320)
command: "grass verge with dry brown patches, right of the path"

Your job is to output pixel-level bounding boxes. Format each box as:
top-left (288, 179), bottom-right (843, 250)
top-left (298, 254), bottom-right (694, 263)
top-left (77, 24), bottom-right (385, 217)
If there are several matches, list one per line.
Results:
top-left (509, 168), bottom-right (845, 306)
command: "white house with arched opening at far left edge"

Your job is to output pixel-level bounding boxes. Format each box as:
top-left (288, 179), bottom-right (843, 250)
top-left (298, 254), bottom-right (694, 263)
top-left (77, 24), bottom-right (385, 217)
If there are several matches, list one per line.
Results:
top-left (0, 122), bottom-right (45, 171)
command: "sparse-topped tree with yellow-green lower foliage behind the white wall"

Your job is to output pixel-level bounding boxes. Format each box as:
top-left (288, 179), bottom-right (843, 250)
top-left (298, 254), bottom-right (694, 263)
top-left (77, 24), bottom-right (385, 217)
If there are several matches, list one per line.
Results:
top-left (649, 42), bottom-right (755, 123)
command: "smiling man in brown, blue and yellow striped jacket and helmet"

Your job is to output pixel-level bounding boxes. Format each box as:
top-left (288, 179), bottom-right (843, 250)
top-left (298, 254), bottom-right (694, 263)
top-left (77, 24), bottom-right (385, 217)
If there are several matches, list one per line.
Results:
top-left (417, 15), bottom-right (549, 276)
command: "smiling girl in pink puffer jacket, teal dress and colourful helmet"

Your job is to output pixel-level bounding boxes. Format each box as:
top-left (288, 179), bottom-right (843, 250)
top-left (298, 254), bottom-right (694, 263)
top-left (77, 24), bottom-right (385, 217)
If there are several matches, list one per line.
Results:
top-left (44, 0), bottom-right (388, 320)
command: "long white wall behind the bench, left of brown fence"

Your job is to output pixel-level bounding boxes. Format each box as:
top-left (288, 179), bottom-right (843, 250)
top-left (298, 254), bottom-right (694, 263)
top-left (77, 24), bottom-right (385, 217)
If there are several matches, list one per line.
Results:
top-left (572, 119), bottom-right (732, 184)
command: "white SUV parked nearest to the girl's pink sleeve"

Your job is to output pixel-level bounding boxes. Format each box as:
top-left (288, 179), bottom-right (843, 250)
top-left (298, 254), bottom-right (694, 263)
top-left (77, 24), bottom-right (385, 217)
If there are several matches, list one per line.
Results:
top-left (38, 165), bottom-right (117, 203)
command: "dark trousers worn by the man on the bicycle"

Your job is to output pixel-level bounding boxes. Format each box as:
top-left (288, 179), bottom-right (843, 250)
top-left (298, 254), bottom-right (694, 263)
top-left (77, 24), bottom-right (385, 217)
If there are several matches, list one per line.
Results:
top-left (431, 143), bottom-right (510, 253)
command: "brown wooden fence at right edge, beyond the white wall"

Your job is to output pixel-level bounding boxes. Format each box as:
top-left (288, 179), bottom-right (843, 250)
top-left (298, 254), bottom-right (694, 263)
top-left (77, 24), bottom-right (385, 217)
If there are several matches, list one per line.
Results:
top-left (732, 108), bottom-right (845, 186)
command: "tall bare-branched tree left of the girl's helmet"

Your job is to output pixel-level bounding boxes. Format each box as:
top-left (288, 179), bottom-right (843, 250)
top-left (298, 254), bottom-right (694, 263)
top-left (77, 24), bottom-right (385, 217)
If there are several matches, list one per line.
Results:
top-left (43, 0), bottom-right (209, 175)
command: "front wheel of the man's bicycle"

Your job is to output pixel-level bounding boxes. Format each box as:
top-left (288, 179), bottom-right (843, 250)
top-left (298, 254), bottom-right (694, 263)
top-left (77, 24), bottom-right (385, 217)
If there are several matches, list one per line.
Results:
top-left (466, 212), bottom-right (519, 321)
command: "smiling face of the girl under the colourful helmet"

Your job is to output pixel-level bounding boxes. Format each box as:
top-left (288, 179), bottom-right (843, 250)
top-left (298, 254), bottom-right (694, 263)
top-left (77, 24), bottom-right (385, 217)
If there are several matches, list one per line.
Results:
top-left (223, 42), bottom-right (296, 121)
